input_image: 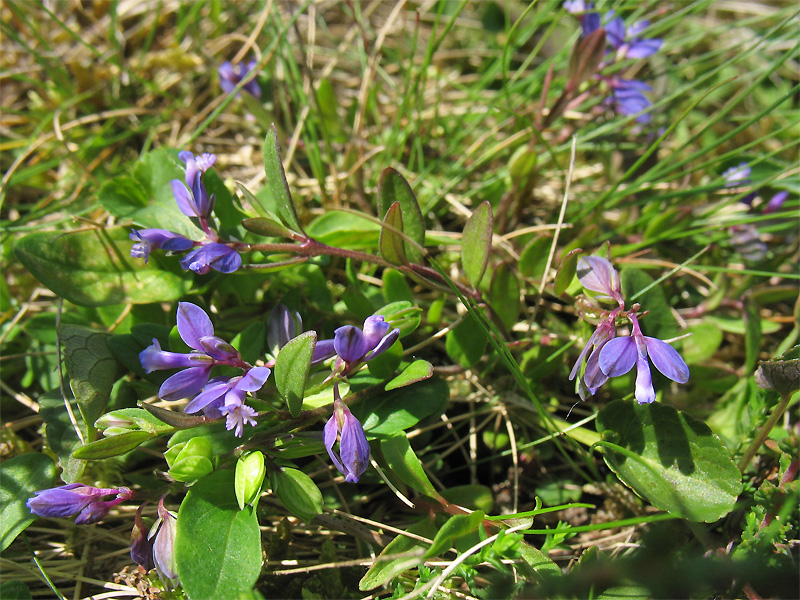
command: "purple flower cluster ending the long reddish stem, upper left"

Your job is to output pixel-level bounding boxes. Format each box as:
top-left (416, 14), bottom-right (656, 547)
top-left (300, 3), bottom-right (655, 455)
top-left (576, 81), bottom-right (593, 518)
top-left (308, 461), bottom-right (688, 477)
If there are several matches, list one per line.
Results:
top-left (130, 151), bottom-right (242, 275)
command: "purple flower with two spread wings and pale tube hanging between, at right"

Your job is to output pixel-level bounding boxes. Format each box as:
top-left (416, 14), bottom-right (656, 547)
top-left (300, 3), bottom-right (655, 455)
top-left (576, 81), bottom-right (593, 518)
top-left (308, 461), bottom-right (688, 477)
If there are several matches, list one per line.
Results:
top-left (599, 312), bottom-right (689, 404)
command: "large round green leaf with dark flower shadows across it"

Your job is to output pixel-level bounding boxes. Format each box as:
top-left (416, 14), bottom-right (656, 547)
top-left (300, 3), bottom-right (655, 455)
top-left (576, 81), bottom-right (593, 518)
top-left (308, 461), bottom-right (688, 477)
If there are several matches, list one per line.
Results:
top-left (597, 400), bottom-right (742, 523)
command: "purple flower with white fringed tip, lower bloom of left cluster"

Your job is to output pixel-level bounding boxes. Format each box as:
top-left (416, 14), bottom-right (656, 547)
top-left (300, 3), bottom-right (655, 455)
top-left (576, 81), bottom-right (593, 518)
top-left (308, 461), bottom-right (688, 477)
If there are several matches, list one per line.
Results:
top-left (184, 367), bottom-right (271, 437)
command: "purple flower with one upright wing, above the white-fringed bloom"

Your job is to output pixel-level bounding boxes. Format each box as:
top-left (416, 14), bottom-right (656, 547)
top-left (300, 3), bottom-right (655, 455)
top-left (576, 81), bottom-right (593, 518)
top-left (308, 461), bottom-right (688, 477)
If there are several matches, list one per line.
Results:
top-left (139, 302), bottom-right (244, 400)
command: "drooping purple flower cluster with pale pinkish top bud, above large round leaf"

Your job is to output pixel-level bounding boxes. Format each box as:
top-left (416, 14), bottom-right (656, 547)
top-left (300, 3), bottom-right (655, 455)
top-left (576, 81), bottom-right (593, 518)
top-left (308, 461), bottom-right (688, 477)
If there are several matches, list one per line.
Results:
top-left (569, 256), bottom-right (689, 404)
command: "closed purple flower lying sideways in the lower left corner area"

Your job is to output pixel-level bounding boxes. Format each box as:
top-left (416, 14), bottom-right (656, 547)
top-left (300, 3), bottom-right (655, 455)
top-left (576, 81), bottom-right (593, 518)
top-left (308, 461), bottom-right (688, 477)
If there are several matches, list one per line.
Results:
top-left (26, 483), bottom-right (133, 525)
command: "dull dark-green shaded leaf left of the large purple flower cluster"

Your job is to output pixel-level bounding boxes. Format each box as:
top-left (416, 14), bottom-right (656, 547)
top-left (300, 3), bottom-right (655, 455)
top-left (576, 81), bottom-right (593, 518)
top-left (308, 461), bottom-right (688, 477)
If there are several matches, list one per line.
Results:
top-left (58, 325), bottom-right (125, 429)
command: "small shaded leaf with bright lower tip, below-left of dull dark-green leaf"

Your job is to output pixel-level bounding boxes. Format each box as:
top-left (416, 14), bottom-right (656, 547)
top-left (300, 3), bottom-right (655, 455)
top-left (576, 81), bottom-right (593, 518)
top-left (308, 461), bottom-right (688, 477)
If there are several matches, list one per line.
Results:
top-left (39, 392), bottom-right (89, 483)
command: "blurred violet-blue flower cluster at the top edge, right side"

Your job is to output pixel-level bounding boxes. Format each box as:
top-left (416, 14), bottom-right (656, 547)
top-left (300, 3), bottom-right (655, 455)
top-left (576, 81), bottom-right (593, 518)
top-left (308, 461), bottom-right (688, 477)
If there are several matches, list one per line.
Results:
top-left (564, 0), bottom-right (663, 123)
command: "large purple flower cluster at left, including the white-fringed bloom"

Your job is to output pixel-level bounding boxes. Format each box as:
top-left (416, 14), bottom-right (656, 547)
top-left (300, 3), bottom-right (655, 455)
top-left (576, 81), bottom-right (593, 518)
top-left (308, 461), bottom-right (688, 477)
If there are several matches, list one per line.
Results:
top-left (139, 302), bottom-right (270, 437)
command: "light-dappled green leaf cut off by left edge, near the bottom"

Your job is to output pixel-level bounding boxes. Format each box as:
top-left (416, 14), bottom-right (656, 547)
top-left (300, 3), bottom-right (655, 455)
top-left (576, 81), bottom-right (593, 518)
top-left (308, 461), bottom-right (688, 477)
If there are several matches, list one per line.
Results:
top-left (0, 452), bottom-right (56, 552)
